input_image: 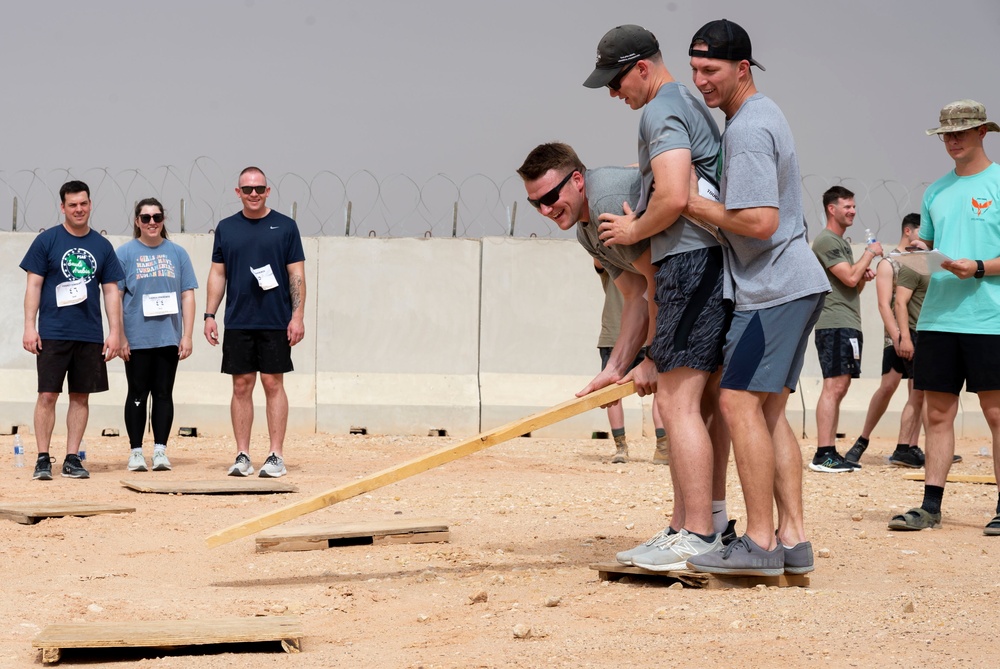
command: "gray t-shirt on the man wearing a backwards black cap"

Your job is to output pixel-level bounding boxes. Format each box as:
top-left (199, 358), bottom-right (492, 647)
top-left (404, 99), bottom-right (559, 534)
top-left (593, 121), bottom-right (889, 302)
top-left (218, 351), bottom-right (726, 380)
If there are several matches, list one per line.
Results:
top-left (720, 93), bottom-right (830, 311)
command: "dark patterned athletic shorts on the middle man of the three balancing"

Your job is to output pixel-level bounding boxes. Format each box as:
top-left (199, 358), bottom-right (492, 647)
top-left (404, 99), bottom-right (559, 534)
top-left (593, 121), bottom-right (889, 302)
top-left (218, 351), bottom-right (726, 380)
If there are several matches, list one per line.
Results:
top-left (648, 246), bottom-right (731, 373)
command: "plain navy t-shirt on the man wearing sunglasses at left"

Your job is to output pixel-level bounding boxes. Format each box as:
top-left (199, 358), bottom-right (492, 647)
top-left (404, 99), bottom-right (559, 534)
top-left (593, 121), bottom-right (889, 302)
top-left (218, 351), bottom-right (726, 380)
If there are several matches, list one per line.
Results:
top-left (212, 209), bottom-right (306, 330)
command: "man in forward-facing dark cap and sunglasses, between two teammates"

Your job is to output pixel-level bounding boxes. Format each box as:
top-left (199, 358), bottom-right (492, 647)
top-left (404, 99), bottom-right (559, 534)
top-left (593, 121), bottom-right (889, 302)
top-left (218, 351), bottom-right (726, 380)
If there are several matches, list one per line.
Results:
top-left (582, 25), bottom-right (729, 571)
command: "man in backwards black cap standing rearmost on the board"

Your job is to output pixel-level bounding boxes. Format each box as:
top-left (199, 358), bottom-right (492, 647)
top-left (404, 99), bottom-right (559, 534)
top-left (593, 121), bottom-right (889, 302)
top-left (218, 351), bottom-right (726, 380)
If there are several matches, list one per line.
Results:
top-left (686, 19), bottom-right (830, 576)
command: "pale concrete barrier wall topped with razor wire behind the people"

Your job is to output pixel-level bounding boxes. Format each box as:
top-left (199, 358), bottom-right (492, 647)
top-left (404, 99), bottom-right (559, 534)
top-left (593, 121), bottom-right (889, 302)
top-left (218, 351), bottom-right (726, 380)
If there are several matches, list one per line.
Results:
top-left (0, 232), bottom-right (988, 440)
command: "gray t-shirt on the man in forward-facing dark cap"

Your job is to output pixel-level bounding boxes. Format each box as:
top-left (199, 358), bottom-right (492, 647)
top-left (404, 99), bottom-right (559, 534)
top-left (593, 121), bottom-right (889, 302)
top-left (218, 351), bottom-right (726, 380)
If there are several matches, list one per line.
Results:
top-left (635, 81), bottom-right (719, 262)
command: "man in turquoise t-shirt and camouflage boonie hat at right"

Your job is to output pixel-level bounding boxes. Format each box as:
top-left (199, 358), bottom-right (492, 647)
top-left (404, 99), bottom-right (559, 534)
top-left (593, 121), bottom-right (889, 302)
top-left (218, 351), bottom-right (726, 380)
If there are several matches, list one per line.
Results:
top-left (889, 100), bottom-right (1000, 536)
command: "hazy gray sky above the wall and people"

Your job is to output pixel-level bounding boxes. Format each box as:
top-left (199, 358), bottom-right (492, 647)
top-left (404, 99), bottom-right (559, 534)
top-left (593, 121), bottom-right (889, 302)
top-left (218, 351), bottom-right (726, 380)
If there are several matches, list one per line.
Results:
top-left (0, 0), bottom-right (1000, 236)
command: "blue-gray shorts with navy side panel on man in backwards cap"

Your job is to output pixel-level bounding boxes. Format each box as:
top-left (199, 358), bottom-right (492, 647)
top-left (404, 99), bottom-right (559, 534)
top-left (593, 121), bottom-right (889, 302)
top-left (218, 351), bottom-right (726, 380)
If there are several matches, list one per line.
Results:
top-left (720, 293), bottom-right (826, 393)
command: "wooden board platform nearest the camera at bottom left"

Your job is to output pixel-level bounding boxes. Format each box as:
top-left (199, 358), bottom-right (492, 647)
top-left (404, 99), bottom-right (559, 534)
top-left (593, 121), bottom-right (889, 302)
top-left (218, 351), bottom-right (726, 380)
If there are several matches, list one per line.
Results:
top-left (31, 616), bottom-right (302, 664)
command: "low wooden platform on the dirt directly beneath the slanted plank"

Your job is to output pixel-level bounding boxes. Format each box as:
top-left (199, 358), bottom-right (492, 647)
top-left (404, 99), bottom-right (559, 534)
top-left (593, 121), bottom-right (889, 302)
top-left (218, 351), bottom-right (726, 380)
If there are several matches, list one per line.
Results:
top-left (257, 518), bottom-right (451, 553)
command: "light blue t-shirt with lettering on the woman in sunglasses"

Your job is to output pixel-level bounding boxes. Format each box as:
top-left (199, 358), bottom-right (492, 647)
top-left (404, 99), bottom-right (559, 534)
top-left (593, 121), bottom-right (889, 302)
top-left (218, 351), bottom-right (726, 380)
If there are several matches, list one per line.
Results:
top-left (118, 239), bottom-right (198, 350)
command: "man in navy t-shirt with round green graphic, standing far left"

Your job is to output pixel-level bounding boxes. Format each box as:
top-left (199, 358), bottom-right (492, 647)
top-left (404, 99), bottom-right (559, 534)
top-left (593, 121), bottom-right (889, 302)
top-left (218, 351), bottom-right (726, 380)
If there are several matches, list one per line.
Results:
top-left (21, 181), bottom-right (125, 481)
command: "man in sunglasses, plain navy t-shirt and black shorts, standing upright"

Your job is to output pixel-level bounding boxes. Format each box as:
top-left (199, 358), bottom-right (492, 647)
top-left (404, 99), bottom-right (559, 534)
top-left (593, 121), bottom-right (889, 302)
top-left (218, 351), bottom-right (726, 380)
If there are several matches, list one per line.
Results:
top-left (205, 167), bottom-right (306, 478)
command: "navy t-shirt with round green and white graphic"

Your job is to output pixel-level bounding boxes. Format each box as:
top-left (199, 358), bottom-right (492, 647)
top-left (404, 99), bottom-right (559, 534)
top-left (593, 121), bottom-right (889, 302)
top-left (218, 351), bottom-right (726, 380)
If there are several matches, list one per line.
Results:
top-left (21, 225), bottom-right (124, 344)
